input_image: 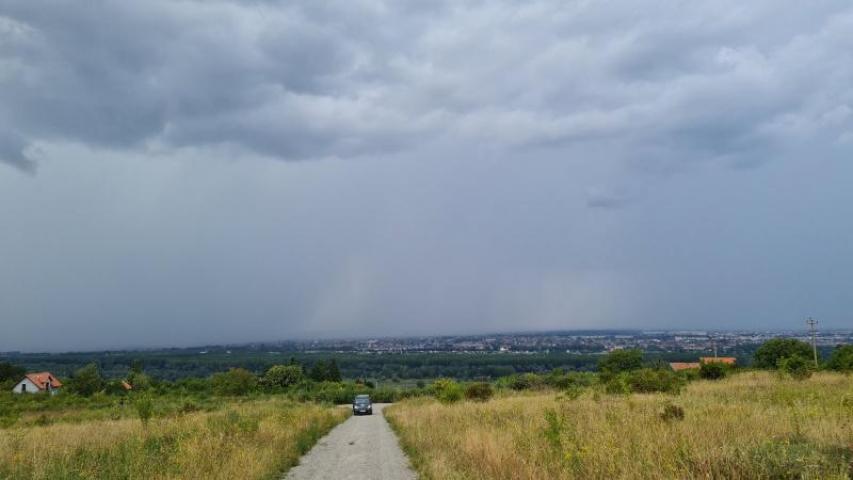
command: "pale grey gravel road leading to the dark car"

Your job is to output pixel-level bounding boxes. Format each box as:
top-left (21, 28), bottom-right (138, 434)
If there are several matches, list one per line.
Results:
top-left (285, 403), bottom-right (417, 480)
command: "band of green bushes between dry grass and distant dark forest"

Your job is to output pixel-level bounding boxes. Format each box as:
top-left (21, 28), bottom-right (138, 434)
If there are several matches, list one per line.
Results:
top-left (0, 339), bottom-right (853, 426)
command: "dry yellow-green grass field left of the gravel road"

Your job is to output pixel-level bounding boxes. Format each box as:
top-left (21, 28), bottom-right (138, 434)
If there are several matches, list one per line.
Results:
top-left (0, 399), bottom-right (349, 480)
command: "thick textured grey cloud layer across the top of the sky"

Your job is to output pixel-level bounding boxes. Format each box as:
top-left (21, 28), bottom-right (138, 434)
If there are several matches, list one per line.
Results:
top-left (0, 0), bottom-right (853, 172)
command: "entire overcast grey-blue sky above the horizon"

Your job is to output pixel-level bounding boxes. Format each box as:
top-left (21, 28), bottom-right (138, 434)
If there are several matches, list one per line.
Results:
top-left (0, 0), bottom-right (853, 351)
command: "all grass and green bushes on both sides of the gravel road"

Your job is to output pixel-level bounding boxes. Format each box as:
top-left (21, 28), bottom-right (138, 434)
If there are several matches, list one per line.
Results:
top-left (0, 340), bottom-right (853, 479)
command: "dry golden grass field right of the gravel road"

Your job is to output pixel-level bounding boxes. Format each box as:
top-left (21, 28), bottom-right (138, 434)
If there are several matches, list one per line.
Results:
top-left (387, 372), bottom-right (853, 480)
